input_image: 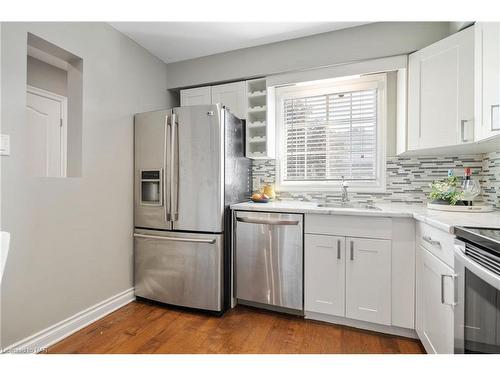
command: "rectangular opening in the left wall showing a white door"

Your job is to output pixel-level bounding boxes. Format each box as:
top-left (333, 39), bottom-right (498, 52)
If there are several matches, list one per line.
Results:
top-left (25, 33), bottom-right (83, 177)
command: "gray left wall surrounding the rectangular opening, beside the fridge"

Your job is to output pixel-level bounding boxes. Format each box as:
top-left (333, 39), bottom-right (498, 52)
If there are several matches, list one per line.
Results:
top-left (0, 23), bottom-right (170, 347)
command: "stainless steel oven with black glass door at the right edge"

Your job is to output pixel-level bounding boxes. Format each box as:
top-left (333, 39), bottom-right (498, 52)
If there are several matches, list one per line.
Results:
top-left (454, 227), bottom-right (500, 353)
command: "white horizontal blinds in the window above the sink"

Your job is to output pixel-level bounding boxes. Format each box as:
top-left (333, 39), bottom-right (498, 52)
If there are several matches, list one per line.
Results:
top-left (283, 89), bottom-right (377, 181)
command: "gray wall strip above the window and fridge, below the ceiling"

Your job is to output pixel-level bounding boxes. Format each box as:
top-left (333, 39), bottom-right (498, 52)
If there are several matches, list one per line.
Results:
top-left (167, 22), bottom-right (452, 88)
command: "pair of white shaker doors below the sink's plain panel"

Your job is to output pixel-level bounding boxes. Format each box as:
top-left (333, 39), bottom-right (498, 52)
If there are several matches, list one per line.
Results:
top-left (305, 234), bottom-right (391, 325)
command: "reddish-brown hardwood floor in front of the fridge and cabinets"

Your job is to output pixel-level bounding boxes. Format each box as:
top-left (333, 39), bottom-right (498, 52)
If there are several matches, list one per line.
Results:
top-left (47, 301), bottom-right (424, 354)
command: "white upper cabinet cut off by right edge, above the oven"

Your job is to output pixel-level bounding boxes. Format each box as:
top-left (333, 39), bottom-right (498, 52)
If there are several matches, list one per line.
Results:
top-left (474, 22), bottom-right (500, 140)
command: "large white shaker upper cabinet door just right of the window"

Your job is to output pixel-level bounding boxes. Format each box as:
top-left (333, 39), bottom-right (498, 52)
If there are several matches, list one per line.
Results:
top-left (408, 27), bottom-right (474, 150)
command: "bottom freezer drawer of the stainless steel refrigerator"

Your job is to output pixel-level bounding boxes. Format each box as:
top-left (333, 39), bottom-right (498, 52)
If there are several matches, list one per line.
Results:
top-left (134, 230), bottom-right (223, 311)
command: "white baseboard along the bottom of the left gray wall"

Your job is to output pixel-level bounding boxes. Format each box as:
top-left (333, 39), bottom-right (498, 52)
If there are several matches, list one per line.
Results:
top-left (3, 288), bottom-right (135, 354)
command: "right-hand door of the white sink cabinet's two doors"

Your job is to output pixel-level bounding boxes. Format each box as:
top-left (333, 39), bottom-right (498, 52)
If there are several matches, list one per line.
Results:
top-left (346, 237), bottom-right (391, 325)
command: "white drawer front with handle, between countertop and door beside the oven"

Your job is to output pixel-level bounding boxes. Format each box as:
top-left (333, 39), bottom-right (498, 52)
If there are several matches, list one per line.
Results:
top-left (416, 222), bottom-right (455, 267)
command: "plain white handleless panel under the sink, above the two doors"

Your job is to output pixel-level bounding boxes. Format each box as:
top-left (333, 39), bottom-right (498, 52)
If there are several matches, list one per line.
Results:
top-left (305, 214), bottom-right (392, 239)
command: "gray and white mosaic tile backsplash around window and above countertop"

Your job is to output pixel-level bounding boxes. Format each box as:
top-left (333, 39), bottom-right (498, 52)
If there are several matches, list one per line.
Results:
top-left (252, 152), bottom-right (500, 208)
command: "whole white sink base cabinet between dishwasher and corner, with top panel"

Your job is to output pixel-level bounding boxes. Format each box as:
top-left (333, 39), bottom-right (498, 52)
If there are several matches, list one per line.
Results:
top-left (304, 214), bottom-right (416, 337)
